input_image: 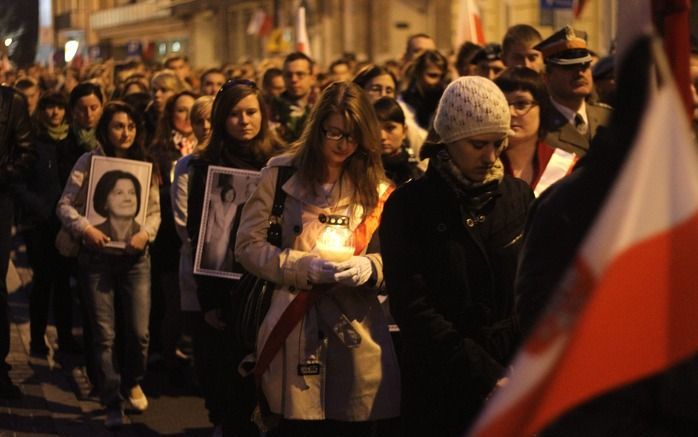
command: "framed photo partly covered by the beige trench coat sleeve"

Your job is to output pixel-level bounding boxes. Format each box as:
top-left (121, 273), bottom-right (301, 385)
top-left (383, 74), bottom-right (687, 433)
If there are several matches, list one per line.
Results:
top-left (194, 166), bottom-right (259, 279)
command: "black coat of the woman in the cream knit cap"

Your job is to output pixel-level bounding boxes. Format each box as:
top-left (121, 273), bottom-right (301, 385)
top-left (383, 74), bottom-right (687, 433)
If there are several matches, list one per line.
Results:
top-left (380, 167), bottom-right (533, 436)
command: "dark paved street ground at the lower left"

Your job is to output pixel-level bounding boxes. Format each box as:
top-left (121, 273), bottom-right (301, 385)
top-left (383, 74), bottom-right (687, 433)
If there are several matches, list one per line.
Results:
top-left (0, 244), bottom-right (213, 437)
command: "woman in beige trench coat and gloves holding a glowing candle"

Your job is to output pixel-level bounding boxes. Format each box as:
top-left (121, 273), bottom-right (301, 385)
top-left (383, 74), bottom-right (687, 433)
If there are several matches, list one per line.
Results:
top-left (235, 82), bottom-right (399, 437)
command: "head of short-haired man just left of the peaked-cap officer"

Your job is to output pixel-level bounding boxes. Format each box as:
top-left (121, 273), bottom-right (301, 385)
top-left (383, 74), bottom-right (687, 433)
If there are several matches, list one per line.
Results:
top-left (502, 24), bottom-right (544, 73)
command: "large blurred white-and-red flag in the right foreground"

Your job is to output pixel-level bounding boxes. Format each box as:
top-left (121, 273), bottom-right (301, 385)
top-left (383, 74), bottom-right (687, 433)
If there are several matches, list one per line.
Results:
top-left (469, 36), bottom-right (698, 437)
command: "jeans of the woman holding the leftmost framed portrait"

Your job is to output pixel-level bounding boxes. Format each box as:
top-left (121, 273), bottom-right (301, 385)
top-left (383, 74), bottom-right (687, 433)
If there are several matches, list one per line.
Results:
top-left (78, 248), bottom-right (150, 408)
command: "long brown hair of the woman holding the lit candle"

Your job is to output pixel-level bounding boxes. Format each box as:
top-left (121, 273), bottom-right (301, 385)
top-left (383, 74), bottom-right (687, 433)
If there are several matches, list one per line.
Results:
top-left (292, 82), bottom-right (385, 214)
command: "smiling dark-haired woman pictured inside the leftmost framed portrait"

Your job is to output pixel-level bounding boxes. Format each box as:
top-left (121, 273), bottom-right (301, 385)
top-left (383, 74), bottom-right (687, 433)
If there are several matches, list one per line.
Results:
top-left (92, 170), bottom-right (142, 247)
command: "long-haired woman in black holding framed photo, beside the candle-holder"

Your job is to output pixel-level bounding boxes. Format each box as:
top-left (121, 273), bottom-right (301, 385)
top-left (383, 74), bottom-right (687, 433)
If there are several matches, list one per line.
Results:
top-left (187, 80), bottom-right (283, 437)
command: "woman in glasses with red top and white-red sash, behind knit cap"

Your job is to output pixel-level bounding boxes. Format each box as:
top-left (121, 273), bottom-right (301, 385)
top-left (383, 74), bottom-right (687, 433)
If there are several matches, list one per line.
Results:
top-left (494, 66), bottom-right (578, 196)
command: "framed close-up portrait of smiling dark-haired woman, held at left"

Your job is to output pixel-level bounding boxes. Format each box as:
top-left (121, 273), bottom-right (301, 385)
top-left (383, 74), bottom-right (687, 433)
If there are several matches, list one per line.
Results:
top-left (85, 156), bottom-right (153, 249)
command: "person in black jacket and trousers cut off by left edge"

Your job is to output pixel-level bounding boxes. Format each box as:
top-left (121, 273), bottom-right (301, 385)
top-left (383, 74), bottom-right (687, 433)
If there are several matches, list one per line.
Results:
top-left (0, 85), bottom-right (37, 399)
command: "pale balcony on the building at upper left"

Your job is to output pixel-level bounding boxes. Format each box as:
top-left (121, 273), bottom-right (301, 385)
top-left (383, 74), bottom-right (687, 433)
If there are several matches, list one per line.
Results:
top-left (90, 0), bottom-right (175, 30)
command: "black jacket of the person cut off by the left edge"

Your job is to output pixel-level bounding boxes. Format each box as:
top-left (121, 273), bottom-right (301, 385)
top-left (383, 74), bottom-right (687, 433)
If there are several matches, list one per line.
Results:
top-left (0, 85), bottom-right (37, 191)
